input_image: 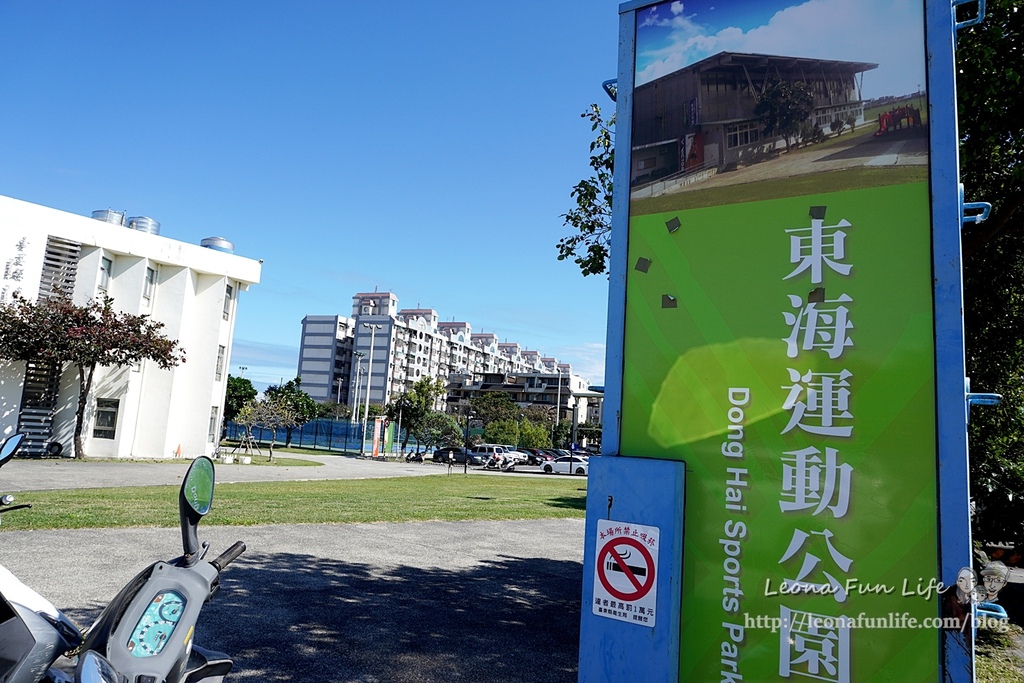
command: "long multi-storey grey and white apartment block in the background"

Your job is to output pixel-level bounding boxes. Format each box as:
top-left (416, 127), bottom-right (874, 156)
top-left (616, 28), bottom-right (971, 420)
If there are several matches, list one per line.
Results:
top-left (298, 292), bottom-right (592, 422)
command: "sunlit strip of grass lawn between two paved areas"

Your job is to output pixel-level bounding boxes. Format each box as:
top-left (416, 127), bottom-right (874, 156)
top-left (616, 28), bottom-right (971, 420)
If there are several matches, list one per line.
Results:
top-left (0, 474), bottom-right (587, 531)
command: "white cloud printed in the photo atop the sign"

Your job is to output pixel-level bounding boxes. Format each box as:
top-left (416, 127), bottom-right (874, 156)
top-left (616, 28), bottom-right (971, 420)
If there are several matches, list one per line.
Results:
top-left (637, 0), bottom-right (925, 97)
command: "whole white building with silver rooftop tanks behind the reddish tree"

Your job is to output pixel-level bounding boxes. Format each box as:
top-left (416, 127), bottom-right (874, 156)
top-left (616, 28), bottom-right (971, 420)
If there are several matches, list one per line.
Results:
top-left (0, 197), bottom-right (260, 458)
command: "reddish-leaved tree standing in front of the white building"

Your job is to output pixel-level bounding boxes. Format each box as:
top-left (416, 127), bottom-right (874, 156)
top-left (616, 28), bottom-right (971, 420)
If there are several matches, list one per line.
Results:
top-left (0, 295), bottom-right (185, 458)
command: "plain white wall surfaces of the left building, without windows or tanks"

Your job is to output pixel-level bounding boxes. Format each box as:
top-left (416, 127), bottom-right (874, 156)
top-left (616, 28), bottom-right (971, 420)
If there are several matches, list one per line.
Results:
top-left (0, 197), bottom-right (260, 458)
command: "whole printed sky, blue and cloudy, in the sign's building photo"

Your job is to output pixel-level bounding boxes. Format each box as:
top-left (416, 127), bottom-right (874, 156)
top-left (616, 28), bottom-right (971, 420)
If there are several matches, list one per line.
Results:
top-left (637, 0), bottom-right (925, 98)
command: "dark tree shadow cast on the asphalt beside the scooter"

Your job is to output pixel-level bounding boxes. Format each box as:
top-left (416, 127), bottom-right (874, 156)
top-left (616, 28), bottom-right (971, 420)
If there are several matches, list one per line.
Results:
top-left (69, 557), bottom-right (582, 683)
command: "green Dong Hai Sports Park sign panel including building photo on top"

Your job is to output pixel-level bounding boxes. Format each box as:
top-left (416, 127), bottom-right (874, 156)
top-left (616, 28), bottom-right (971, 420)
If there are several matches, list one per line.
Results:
top-left (620, 0), bottom-right (942, 681)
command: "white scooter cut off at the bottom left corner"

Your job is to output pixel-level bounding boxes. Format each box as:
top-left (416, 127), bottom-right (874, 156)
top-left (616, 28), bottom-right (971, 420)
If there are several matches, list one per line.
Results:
top-left (0, 434), bottom-right (82, 683)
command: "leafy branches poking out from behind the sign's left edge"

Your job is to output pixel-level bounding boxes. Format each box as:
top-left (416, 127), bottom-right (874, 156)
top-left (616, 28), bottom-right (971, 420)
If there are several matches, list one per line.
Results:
top-left (557, 104), bottom-right (615, 275)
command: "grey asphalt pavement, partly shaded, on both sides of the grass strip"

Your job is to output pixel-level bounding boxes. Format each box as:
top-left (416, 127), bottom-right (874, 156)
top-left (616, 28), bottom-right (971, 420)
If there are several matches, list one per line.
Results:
top-left (0, 459), bottom-right (584, 683)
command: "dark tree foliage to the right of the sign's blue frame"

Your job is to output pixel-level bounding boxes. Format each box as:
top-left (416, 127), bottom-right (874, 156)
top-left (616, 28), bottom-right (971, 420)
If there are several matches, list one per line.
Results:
top-left (956, 0), bottom-right (1024, 542)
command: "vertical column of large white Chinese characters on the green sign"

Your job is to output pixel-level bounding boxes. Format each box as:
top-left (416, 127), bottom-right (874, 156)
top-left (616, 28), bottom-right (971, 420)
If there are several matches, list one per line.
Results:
top-left (778, 206), bottom-right (855, 683)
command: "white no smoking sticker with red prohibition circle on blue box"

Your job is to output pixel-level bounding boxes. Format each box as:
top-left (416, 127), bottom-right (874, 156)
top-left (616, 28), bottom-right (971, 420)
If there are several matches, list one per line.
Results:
top-left (593, 519), bottom-right (659, 627)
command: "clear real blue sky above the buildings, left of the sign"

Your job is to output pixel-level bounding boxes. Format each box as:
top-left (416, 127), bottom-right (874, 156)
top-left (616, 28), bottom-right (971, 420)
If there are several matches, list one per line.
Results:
top-left (0, 0), bottom-right (618, 385)
